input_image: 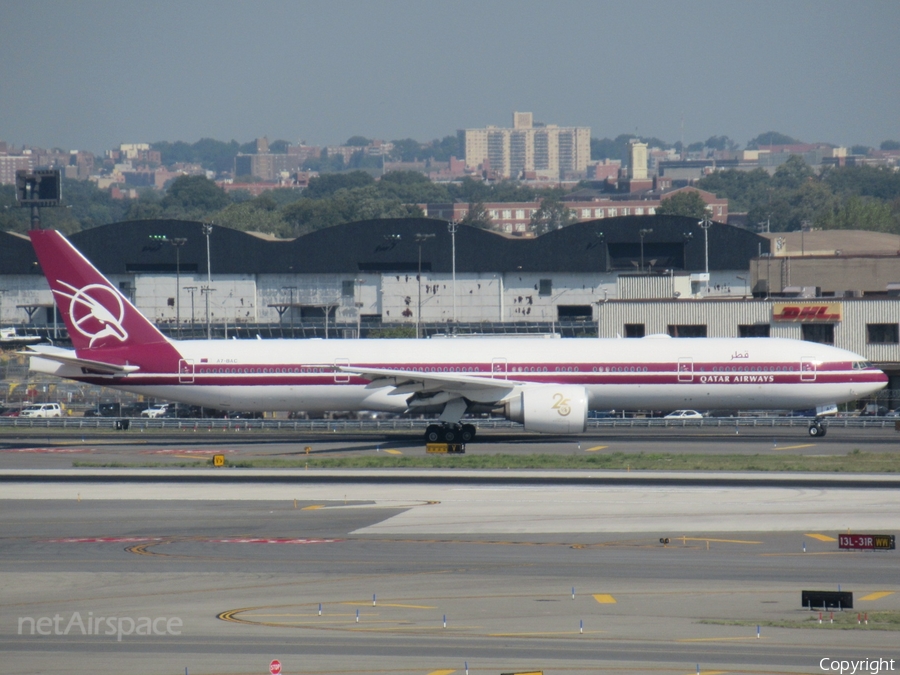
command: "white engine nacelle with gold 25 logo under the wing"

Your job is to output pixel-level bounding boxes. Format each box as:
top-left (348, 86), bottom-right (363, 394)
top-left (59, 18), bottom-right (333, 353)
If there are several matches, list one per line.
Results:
top-left (504, 384), bottom-right (588, 434)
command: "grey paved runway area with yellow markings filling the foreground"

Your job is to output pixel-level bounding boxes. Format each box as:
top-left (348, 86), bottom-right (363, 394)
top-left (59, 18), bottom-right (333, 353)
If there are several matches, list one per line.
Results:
top-left (0, 468), bottom-right (900, 675)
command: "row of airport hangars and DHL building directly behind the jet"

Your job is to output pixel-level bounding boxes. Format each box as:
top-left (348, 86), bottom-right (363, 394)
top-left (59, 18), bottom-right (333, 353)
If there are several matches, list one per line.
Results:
top-left (0, 215), bottom-right (900, 396)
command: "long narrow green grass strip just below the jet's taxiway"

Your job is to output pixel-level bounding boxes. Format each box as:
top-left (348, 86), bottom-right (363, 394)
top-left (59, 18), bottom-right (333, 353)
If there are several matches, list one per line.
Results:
top-left (72, 450), bottom-right (900, 473)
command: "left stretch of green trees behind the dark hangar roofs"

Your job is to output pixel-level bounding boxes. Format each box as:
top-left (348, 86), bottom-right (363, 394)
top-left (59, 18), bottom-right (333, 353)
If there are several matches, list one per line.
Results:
top-left (0, 171), bottom-right (571, 238)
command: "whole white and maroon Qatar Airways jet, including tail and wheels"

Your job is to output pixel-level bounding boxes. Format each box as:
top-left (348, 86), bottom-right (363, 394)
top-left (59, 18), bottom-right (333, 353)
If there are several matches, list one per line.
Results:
top-left (24, 230), bottom-right (887, 442)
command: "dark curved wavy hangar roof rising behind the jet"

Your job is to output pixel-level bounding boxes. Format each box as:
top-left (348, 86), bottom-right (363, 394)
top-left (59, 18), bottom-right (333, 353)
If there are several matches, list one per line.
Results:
top-left (0, 216), bottom-right (769, 274)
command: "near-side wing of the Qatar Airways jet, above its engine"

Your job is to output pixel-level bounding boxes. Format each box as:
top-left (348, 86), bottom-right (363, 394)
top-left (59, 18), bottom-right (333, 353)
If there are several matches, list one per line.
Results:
top-left (338, 366), bottom-right (528, 402)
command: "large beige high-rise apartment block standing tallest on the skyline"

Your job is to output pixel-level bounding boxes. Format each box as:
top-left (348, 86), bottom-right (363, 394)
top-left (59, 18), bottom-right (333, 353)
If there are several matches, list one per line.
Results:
top-left (457, 112), bottom-right (591, 180)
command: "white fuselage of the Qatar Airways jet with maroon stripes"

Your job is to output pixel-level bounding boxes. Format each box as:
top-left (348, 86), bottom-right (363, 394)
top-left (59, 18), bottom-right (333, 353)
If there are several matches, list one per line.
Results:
top-left (32, 337), bottom-right (886, 412)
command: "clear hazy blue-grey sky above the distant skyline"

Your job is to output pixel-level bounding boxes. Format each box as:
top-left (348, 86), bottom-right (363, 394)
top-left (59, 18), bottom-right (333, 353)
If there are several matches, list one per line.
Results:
top-left (0, 0), bottom-right (900, 152)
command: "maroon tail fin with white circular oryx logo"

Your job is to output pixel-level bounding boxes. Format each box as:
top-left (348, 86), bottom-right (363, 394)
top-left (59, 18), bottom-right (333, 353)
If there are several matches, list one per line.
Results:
top-left (29, 230), bottom-right (180, 372)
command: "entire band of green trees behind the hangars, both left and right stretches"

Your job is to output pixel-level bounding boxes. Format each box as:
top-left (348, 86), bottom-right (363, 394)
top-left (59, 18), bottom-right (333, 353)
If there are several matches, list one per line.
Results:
top-left (0, 152), bottom-right (900, 238)
